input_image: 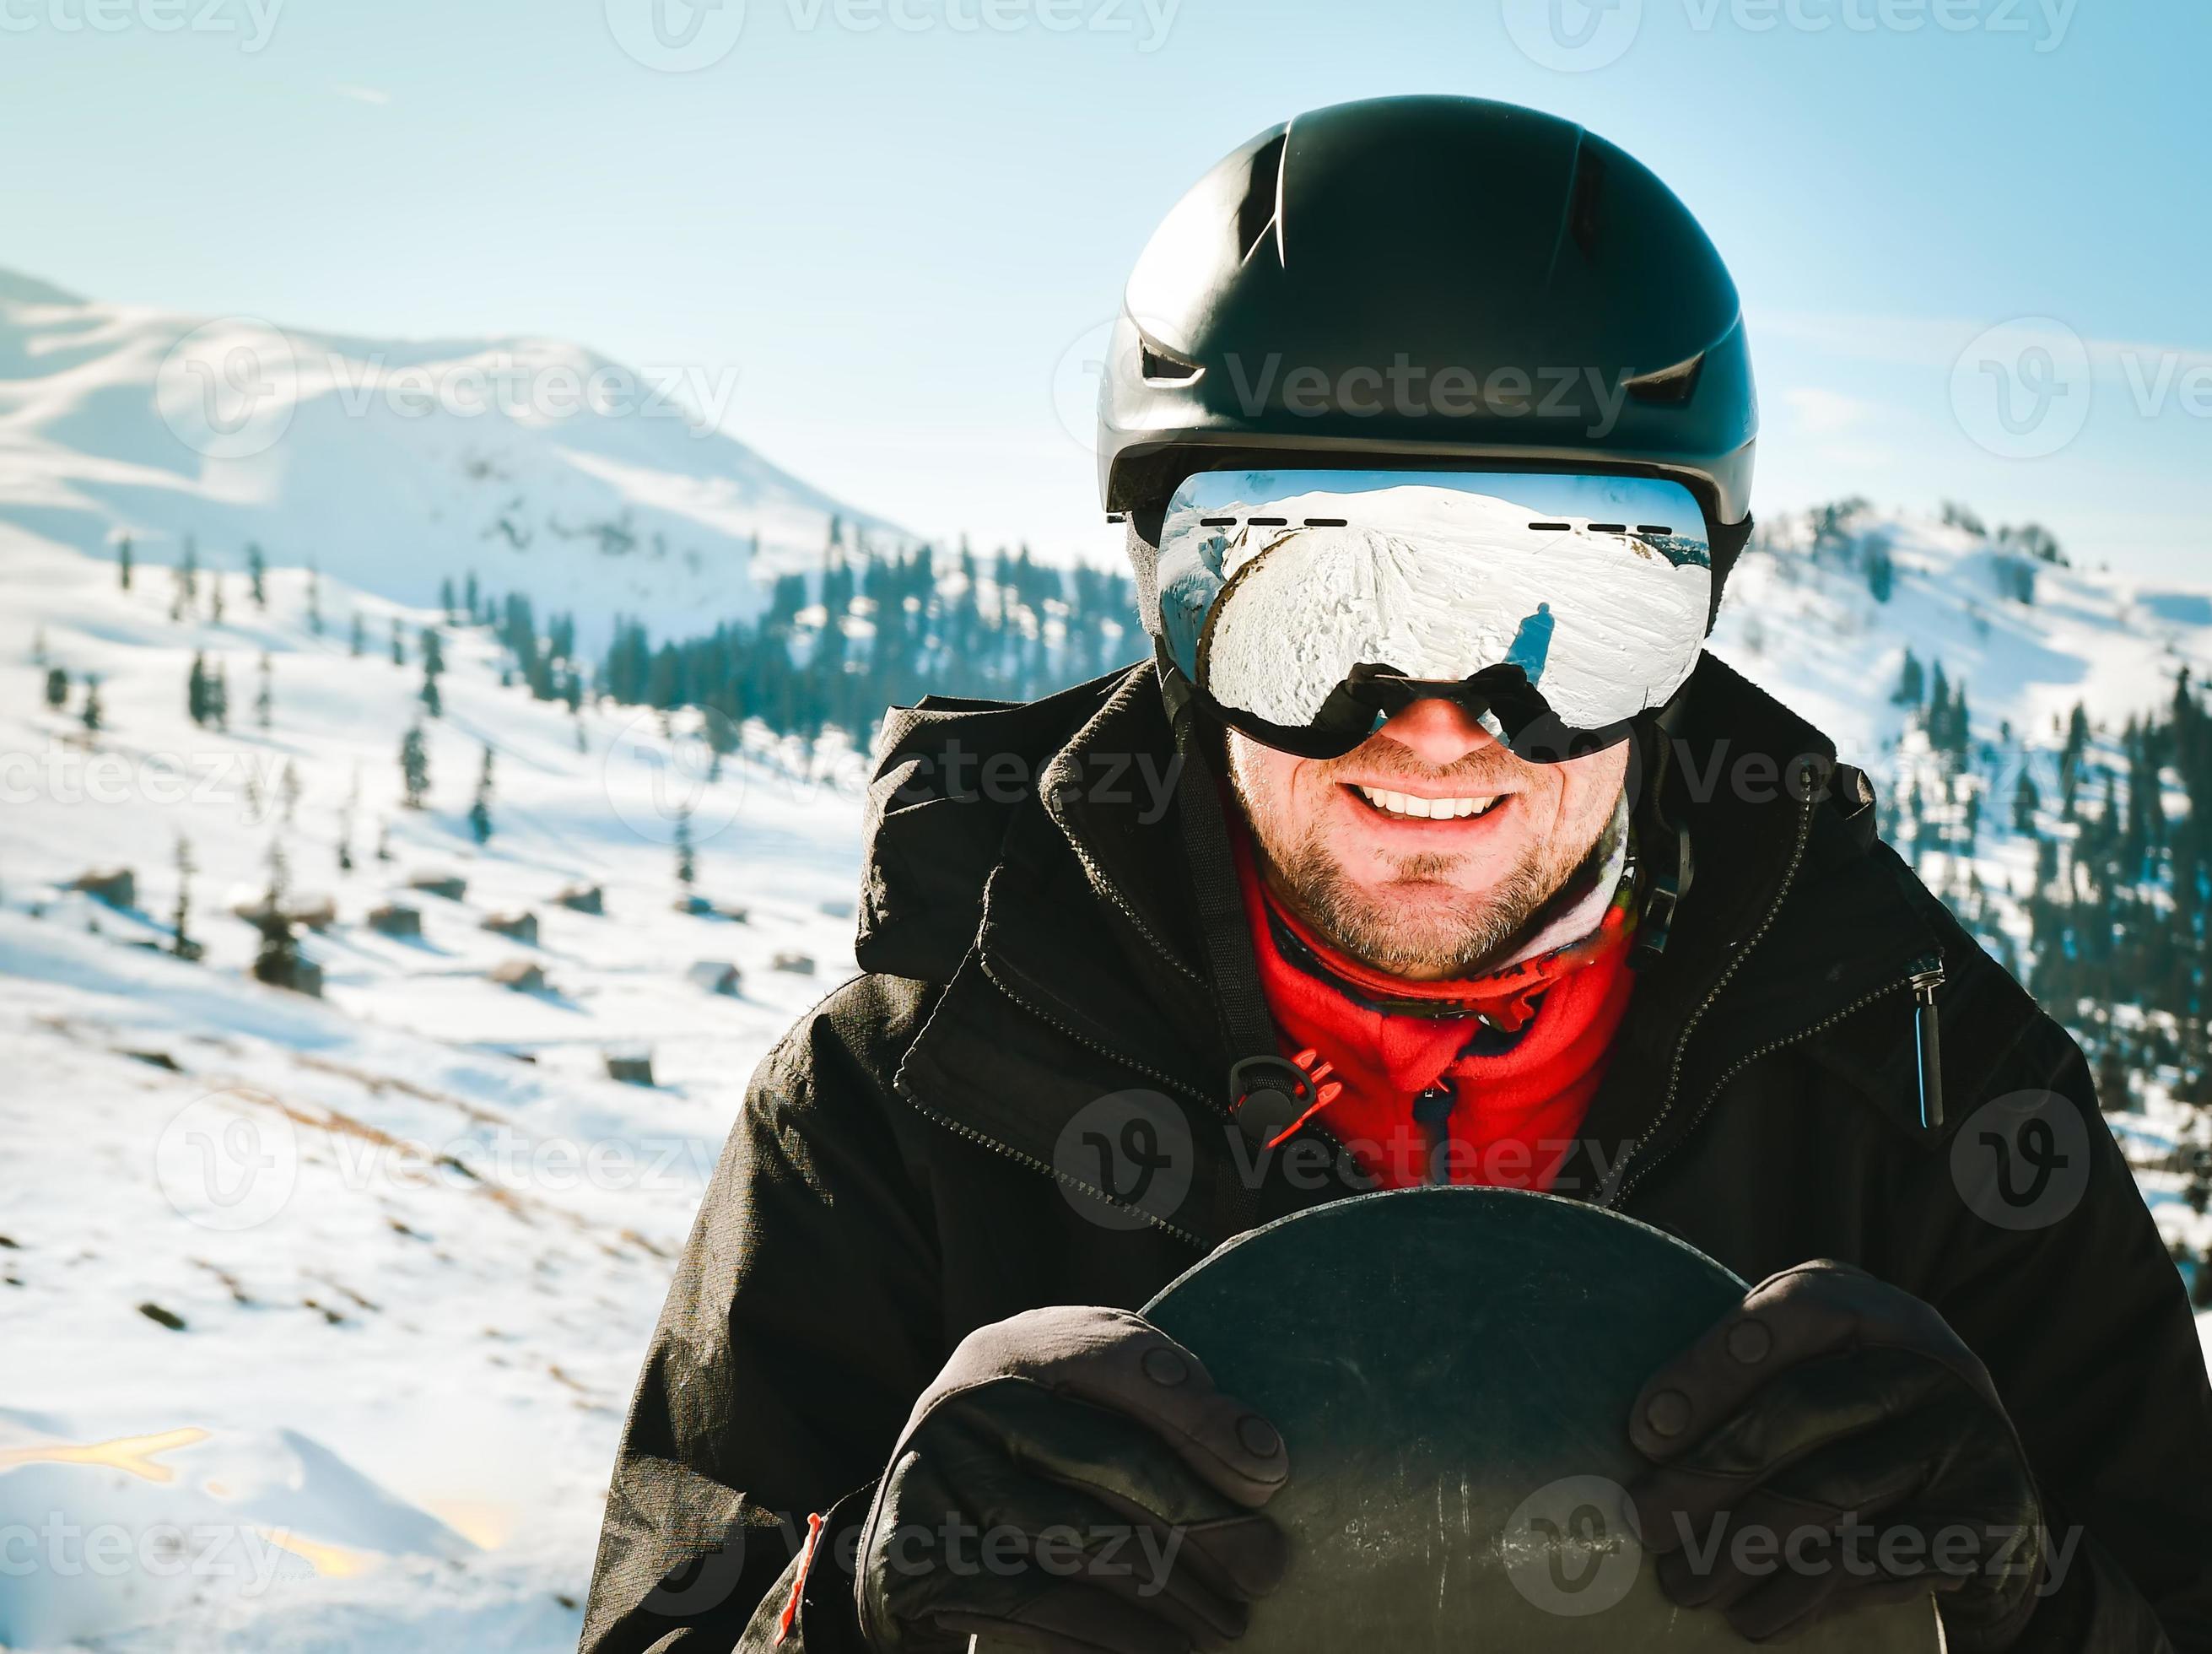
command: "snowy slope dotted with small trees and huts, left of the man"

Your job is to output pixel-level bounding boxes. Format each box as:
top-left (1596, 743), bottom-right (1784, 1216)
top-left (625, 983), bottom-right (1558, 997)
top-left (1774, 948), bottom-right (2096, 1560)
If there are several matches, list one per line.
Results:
top-left (0, 527), bottom-right (861, 1650)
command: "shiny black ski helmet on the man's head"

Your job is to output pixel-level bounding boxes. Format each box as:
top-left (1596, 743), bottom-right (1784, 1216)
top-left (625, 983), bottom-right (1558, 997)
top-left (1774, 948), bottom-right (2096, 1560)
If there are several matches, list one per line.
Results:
top-left (1098, 97), bottom-right (1758, 628)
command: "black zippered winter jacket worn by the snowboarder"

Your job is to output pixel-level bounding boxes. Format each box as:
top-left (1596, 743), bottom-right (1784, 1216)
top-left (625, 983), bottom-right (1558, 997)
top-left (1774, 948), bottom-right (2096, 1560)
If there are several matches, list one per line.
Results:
top-left (582, 657), bottom-right (2212, 1654)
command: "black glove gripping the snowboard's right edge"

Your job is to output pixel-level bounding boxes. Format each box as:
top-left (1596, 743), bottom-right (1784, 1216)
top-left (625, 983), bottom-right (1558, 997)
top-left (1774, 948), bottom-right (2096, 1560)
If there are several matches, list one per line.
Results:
top-left (1628, 1262), bottom-right (2044, 1654)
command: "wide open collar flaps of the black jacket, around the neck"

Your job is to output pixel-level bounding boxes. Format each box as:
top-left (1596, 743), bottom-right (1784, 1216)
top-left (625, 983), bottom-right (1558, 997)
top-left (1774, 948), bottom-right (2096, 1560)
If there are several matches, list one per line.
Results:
top-left (861, 655), bottom-right (1935, 1227)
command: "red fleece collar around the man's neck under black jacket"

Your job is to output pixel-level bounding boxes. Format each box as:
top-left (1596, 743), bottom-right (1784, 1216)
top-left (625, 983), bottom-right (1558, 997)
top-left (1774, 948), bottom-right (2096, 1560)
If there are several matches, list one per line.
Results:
top-left (1232, 831), bottom-right (1635, 1190)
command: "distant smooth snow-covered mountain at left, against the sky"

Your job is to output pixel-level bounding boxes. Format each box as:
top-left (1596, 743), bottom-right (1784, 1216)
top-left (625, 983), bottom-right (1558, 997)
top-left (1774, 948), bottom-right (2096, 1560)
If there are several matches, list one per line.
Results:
top-left (0, 270), bottom-right (907, 648)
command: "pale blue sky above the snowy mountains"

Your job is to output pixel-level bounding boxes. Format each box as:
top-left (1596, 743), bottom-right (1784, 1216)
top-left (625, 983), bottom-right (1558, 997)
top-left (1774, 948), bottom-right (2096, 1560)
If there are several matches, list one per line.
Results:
top-left (0, 0), bottom-right (2212, 581)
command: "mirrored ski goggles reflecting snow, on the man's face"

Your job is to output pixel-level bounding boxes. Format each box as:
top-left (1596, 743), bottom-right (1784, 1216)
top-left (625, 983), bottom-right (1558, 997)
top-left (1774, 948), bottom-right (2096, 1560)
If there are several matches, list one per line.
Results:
top-left (1157, 471), bottom-right (1712, 759)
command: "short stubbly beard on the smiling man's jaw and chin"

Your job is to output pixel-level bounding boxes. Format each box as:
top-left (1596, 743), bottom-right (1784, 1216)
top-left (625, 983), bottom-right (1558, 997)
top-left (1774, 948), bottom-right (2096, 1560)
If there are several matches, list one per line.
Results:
top-left (1227, 738), bottom-right (1610, 977)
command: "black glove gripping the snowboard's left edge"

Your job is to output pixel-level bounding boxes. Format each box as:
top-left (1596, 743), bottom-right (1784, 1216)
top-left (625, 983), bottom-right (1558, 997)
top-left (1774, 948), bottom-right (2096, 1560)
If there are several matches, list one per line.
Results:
top-left (854, 1307), bottom-right (1290, 1654)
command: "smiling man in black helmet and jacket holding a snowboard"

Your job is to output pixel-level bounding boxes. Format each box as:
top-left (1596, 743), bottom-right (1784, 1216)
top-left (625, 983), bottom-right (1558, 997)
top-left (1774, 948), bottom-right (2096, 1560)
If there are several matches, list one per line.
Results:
top-left (584, 97), bottom-right (2212, 1654)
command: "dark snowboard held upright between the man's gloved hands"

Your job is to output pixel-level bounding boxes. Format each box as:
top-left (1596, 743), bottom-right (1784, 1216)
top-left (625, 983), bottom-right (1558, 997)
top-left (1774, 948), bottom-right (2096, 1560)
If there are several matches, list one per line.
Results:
top-left (1123, 1187), bottom-right (1942, 1654)
